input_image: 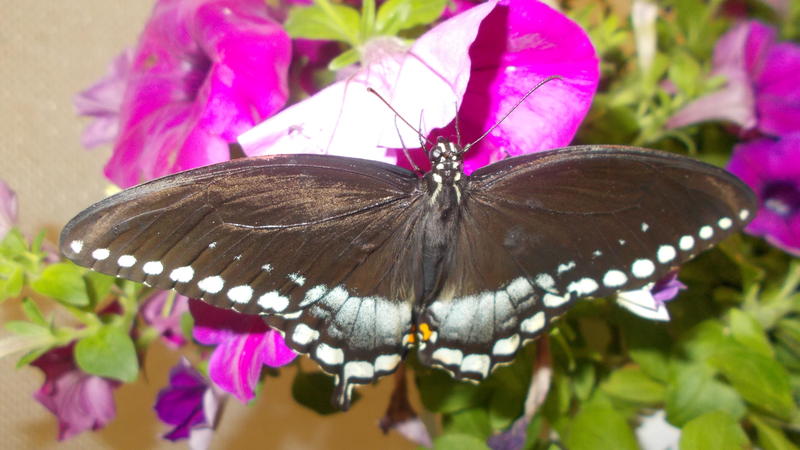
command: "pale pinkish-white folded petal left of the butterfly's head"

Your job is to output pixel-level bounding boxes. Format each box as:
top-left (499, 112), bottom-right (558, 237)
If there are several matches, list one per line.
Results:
top-left (238, 1), bottom-right (496, 162)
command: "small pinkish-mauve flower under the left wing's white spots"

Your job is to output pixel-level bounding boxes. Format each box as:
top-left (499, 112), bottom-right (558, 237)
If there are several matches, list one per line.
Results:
top-left (140, 291), bottom-right (189, 348)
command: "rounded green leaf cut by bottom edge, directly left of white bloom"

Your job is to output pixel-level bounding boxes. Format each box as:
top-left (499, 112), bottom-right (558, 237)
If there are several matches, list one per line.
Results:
top-left (564, 404), bottom-right (639, 450)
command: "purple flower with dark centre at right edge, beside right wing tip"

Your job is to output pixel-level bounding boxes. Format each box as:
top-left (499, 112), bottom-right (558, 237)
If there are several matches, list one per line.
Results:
top-left (728, 131), bottom-right (800, 256)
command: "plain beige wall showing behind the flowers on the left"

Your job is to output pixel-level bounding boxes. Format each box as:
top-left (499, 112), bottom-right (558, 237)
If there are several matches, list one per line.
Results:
top-left (0, 0), bottom-right (411, 450)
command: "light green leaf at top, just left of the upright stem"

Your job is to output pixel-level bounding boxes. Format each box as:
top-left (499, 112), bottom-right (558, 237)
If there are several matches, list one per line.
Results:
top-left (283, 1), bottom-right (360, 47)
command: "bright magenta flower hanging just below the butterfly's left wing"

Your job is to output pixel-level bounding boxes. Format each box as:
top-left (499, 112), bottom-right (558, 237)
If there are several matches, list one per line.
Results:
top-left (189, 300), bottom-right (297, 402)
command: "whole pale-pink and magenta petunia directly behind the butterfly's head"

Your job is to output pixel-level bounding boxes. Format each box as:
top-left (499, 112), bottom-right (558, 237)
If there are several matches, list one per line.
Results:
top-left (239, 0), bottom-right (598, 171)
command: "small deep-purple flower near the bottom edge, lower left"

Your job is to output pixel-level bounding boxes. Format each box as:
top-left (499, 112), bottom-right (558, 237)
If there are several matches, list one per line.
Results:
top-left (154, 359), bottom-right (222, 448)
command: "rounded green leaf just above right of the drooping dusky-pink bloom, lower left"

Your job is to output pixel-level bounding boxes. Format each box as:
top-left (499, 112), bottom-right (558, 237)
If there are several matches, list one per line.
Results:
top-left (75, 325), bottom-right (139, 383)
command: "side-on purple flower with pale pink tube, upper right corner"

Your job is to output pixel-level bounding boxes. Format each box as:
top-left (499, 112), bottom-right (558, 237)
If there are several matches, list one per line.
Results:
top-left (667, 21), bottom-right (800, 135)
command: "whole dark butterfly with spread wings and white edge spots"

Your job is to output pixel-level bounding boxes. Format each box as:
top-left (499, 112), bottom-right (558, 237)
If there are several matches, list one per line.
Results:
top-left (61, 140), bottom-right (756, 408)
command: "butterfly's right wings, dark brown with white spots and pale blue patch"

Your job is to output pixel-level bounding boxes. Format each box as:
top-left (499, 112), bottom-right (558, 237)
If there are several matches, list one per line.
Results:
top-left (419, 146), bottom-right (756, 379)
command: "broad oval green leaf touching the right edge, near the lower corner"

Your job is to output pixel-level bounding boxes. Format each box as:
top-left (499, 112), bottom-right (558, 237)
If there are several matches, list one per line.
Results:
top-left (709, 343), bottom-right (796, 420)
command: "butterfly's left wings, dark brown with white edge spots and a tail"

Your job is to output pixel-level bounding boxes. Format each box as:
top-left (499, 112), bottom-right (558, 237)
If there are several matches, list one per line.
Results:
top-left (61, 155), bottom-right (421, 407)
